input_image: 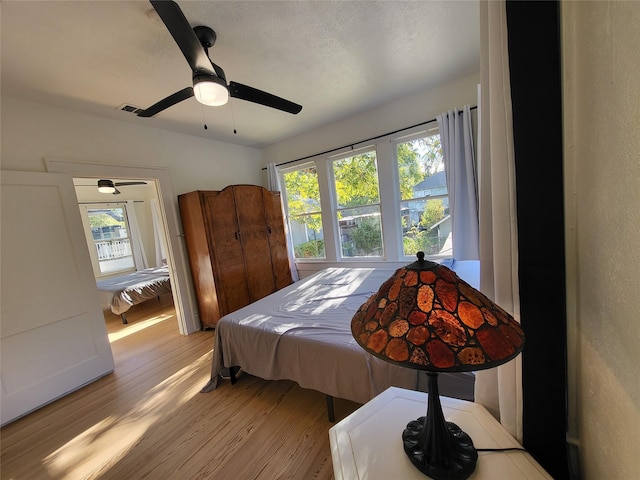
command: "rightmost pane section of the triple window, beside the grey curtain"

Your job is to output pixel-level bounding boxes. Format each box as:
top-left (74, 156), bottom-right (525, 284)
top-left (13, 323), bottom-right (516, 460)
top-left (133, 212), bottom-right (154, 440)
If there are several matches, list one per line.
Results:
top-left (395, 133), bottom-right (452, 257)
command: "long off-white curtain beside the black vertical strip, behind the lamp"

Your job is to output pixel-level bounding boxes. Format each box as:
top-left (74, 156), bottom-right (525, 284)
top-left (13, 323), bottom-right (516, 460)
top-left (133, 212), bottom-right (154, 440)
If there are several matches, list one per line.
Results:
top-left (475, 0), bottom-right (526, 441)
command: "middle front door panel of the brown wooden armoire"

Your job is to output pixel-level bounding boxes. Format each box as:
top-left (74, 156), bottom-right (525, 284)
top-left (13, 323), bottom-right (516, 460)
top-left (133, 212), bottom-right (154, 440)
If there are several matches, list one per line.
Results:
top-left (232, 185), bottom-right (276, 302)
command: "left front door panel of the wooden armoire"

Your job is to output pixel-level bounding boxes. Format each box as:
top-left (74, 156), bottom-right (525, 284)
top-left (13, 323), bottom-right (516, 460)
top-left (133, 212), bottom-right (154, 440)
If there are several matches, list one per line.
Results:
top-left (201, 188), bottom-right (251, 315)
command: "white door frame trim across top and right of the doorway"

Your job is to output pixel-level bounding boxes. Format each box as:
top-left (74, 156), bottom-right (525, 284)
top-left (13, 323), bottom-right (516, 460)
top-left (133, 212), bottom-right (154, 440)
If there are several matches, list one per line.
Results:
top-left (45, 158), bottom-right (200, 335)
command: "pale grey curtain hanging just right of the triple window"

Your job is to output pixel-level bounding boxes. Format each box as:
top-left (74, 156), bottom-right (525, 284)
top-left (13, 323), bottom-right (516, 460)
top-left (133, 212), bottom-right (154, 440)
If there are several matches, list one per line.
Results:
top-left (436, 105), bottom-right (480, 260)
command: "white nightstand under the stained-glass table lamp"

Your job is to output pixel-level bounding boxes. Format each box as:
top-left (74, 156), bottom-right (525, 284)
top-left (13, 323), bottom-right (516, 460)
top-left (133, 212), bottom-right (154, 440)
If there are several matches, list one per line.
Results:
top-left (329, 387), bottom-right (552, 480)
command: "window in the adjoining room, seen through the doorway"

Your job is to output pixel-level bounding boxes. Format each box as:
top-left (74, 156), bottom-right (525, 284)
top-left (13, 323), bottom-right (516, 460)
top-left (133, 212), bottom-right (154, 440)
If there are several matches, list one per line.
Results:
top-left (85, 205), bottom-right (135, 276)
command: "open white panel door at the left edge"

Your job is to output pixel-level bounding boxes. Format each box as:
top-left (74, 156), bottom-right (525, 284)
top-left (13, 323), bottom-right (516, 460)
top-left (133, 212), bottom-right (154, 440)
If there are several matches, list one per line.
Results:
top-left (0, 171), bottom-right (114, 424)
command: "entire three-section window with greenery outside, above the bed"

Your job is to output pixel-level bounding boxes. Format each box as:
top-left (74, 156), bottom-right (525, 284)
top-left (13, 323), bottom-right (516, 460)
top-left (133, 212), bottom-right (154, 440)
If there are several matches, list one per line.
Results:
top-left (279, 122), bottom-right (468, 264)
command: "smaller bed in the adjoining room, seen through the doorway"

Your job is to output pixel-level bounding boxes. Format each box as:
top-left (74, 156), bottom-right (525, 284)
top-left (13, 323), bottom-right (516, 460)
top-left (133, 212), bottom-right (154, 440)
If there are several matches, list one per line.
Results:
top-left (96, 266), bottom-right (171, 324)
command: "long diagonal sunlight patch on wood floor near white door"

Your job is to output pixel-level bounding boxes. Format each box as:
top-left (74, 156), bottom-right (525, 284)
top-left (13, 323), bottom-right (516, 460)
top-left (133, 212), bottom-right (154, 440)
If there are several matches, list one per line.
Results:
top-left (42, 348), bottom-right (211, 479)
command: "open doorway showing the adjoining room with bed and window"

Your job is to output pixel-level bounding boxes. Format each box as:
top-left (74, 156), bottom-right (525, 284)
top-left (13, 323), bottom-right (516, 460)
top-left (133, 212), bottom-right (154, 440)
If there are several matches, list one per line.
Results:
top-left (73, 177), bottom-right (175, 334)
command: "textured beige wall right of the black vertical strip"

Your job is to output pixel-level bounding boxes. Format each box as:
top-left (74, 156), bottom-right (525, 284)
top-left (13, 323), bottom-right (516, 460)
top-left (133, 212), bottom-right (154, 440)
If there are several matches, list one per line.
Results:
top-left (561, 1), bottom-right (640, 480)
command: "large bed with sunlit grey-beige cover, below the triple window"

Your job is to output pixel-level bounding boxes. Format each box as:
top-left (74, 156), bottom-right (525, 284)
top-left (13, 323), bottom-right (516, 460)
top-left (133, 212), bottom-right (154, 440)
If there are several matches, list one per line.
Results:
top-left (202, 268), bottom-right (473, 418)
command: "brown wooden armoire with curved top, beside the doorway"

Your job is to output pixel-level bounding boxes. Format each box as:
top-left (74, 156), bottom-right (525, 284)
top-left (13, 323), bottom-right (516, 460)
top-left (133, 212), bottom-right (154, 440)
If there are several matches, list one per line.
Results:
top-left (178, 185), bottom-right (292, 329)
